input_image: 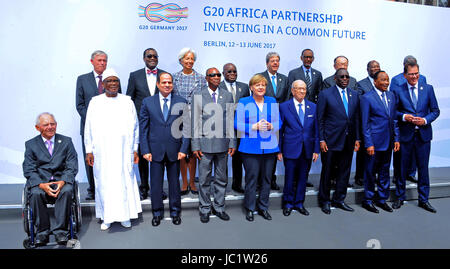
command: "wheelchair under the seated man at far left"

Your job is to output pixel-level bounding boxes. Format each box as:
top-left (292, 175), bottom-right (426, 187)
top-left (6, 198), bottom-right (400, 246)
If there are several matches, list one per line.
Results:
top-left (22, 180), bottom-right (82, 249)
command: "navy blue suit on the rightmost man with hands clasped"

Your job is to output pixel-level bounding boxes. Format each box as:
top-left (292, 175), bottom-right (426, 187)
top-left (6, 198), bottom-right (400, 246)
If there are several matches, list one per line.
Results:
top-left (394, 82), bottom-right (440, 203)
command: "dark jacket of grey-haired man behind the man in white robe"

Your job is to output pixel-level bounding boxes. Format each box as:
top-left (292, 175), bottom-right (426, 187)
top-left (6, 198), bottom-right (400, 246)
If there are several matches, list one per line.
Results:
top-left (76, 71), bottom-right (122, 135)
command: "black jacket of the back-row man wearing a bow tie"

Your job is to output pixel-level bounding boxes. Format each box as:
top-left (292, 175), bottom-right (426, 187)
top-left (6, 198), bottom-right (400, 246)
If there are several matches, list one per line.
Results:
top-left (127, 68), bottom-right (167, 117)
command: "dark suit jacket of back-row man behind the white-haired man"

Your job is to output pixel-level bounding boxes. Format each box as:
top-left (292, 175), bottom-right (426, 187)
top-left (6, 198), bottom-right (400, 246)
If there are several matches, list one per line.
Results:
top-left (288, 66), bottom-right (323, 103)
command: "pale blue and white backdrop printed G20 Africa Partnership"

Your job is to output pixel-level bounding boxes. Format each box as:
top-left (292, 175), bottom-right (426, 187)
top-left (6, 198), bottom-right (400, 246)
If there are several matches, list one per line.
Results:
top-left (0, 0), bottom-right (450, 184)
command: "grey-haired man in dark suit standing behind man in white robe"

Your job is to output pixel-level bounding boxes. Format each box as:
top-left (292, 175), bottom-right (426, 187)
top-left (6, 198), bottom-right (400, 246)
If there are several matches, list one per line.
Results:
top-left (76, 50), bottom-right (121, 200)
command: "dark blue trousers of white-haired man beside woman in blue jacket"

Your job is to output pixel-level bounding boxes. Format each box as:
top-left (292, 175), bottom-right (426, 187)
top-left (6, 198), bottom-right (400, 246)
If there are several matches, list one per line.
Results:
top-left (282, 148), bottom-right (312, 208)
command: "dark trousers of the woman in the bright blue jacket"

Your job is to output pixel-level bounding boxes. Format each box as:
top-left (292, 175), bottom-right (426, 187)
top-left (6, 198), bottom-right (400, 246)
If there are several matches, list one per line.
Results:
top-left (241, 153), bottom-right (276, 211)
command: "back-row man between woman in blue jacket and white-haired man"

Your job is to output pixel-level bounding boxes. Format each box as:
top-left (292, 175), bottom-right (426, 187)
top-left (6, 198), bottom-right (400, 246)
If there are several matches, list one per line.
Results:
top-left (260, 52), bottom-right (290, 190)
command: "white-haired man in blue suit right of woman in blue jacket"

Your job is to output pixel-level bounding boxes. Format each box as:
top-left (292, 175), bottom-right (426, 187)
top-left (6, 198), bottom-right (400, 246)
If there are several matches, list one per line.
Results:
top-left (278, 80), bottom-right (320, 216)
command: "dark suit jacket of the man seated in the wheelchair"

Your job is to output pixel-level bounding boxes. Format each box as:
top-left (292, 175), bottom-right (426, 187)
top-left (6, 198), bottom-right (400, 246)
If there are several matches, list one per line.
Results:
top-left (22, 134), bottom-right (78, 188)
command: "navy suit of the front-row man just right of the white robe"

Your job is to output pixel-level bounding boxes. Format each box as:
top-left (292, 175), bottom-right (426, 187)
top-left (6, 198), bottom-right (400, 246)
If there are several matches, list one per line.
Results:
top-left (139, 94), bottom-right (189, 217)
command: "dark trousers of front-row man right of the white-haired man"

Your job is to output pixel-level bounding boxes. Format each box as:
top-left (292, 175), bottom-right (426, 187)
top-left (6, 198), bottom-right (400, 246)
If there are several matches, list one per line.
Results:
top-left (319, 140), bottom-right (354, 205)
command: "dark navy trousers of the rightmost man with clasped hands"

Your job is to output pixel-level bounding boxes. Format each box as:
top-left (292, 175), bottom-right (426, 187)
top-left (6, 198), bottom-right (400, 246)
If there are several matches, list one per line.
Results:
top-left (395, 132), bottom-right (431, 203)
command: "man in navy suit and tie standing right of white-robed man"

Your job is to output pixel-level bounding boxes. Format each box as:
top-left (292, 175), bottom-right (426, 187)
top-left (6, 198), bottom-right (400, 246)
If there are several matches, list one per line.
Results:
top-left (139, 73), bottom-right (189, 226)
